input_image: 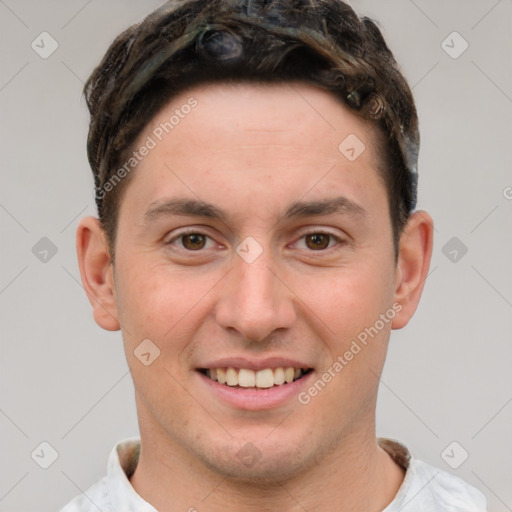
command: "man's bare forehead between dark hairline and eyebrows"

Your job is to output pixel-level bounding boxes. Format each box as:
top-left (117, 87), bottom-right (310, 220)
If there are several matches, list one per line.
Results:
top-left (124, 82), bottom-right (386, 217)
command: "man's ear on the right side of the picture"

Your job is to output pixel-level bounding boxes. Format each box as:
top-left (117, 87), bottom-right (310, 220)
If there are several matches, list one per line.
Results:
top-left (391, 211), bottom-right (434, 329)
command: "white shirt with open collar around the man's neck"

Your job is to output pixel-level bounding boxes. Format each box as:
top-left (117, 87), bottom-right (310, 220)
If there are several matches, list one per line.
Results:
top-left (61, 438), bottom-right (487, 512)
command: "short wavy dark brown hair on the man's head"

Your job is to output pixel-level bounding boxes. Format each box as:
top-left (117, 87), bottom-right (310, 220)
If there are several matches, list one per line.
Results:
top-left (84, 0), bottom-right (419, 256)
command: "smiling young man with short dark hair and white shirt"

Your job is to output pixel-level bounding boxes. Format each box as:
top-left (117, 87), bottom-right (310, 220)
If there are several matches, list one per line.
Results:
top-left (64, 0), bottom-right (486, 512)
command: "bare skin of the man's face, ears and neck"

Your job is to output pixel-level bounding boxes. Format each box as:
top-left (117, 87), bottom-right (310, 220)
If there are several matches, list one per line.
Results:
top-left (77, 83), bottom-right (432, 512)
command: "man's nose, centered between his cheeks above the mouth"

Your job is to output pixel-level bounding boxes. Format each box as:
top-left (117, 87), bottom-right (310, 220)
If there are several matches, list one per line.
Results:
top-left (215, 253), bottom-right (296, 341)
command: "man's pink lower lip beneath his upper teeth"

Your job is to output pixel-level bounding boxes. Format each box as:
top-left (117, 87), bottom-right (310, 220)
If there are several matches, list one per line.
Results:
top-left (197, 371), bottom-right (314, 411)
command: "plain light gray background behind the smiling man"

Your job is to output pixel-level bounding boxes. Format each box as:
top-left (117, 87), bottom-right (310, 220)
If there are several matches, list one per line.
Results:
top-left (0, 0), bottom-right (512, 512)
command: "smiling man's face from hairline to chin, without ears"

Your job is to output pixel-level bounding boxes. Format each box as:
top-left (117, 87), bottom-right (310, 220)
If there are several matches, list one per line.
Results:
top-left (82, 84), bottom-right (426, 480)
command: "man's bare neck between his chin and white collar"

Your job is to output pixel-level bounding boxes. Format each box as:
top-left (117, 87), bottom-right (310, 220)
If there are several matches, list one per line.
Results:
top-left (131, 414), bottom-right (404, 512)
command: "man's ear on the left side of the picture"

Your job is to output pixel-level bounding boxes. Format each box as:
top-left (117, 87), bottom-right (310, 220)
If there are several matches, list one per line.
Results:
top-left (76, 217), bottom-right (120, 331)
